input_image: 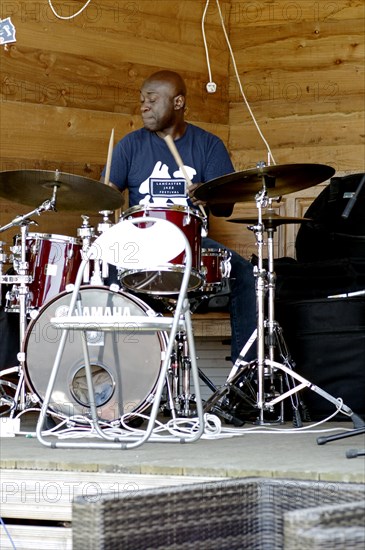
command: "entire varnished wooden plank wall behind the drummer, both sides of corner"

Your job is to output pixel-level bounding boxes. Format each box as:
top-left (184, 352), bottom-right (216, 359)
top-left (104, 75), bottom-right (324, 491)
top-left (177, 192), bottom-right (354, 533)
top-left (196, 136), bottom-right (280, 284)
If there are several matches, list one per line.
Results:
top-left (0, 0), bottom-right (364, 262)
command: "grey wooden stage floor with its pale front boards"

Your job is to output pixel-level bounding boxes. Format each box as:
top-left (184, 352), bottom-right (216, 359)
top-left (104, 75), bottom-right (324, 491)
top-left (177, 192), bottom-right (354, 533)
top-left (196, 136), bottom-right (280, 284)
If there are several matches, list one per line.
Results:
top-left (0, 412), bottom-right (365, 550)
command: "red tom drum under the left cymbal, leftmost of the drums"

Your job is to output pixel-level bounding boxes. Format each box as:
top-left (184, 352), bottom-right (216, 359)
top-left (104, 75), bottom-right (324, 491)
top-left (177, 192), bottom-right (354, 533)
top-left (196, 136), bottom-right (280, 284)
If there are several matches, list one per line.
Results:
top-left (7, 233), bottom-right (82, 311)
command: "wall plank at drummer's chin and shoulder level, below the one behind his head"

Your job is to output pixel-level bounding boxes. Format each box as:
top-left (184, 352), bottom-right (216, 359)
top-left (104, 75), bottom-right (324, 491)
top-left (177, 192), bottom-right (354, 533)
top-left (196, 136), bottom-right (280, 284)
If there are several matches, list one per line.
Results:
top-left (1, 101), bottom-right (228, 169)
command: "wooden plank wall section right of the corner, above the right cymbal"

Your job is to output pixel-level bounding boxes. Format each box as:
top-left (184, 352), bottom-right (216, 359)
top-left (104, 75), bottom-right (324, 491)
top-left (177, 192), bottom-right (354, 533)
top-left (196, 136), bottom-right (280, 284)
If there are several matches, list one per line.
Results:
top-left (206, 0), bottom-right (365, 256)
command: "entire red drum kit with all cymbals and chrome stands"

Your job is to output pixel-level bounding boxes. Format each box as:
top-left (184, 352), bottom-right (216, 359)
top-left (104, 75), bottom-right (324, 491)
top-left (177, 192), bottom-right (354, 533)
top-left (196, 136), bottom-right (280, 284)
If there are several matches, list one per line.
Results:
top-left (0, 160), bottom-right (358, 432)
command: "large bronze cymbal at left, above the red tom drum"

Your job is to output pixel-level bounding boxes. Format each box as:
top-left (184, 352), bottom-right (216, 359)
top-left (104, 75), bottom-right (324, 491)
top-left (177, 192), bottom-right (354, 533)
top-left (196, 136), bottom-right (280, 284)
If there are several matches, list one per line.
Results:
top-left (0, 170), bottom-right (122, 212)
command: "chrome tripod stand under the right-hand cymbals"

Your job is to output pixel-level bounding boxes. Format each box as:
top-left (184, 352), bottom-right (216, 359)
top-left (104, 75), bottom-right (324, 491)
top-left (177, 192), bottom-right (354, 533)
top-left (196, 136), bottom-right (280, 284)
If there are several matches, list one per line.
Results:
top-left (205, 190), bottom-right (312, 427)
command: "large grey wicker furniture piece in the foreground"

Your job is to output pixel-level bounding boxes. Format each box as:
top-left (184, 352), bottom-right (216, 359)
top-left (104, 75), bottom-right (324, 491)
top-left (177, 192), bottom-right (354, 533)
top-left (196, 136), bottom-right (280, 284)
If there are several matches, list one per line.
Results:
top-left (72, 478), bottom-right (364, 550)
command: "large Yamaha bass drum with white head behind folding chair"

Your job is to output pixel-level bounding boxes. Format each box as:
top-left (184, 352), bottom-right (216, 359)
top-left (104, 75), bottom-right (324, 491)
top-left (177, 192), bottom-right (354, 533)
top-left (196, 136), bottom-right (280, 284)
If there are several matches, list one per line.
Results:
top-left (23, 286), bottom-right (167, 421)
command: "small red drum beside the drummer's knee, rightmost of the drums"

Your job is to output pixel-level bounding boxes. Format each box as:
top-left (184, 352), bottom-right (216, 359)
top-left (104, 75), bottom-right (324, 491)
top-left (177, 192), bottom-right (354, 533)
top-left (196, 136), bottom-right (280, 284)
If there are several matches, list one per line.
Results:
top-left (201, 248), bottom-right (230, 292)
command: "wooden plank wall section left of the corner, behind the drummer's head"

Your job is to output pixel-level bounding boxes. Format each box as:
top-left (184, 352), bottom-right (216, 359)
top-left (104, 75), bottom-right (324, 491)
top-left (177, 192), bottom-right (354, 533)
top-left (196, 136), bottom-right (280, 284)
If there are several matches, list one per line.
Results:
top-left (0, 0), bottom-right (229, 248)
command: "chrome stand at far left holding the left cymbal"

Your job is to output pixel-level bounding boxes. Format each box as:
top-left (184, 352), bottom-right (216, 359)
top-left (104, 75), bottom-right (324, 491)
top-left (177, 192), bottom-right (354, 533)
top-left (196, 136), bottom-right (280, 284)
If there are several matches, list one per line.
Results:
top-left (0, 185), bottom-right (57, 417)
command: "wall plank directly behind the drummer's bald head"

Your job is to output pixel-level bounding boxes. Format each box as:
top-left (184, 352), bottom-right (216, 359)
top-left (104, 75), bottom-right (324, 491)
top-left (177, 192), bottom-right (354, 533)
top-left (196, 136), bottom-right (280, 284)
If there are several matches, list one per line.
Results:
top-left (1, 46), bottom-right (228, 123)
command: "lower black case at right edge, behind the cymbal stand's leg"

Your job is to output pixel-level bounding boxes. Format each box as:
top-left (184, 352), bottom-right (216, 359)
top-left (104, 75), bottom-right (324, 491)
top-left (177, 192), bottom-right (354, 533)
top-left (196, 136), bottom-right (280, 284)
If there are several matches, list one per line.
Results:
top-left (276, 296), bottom-right (365, 420)
